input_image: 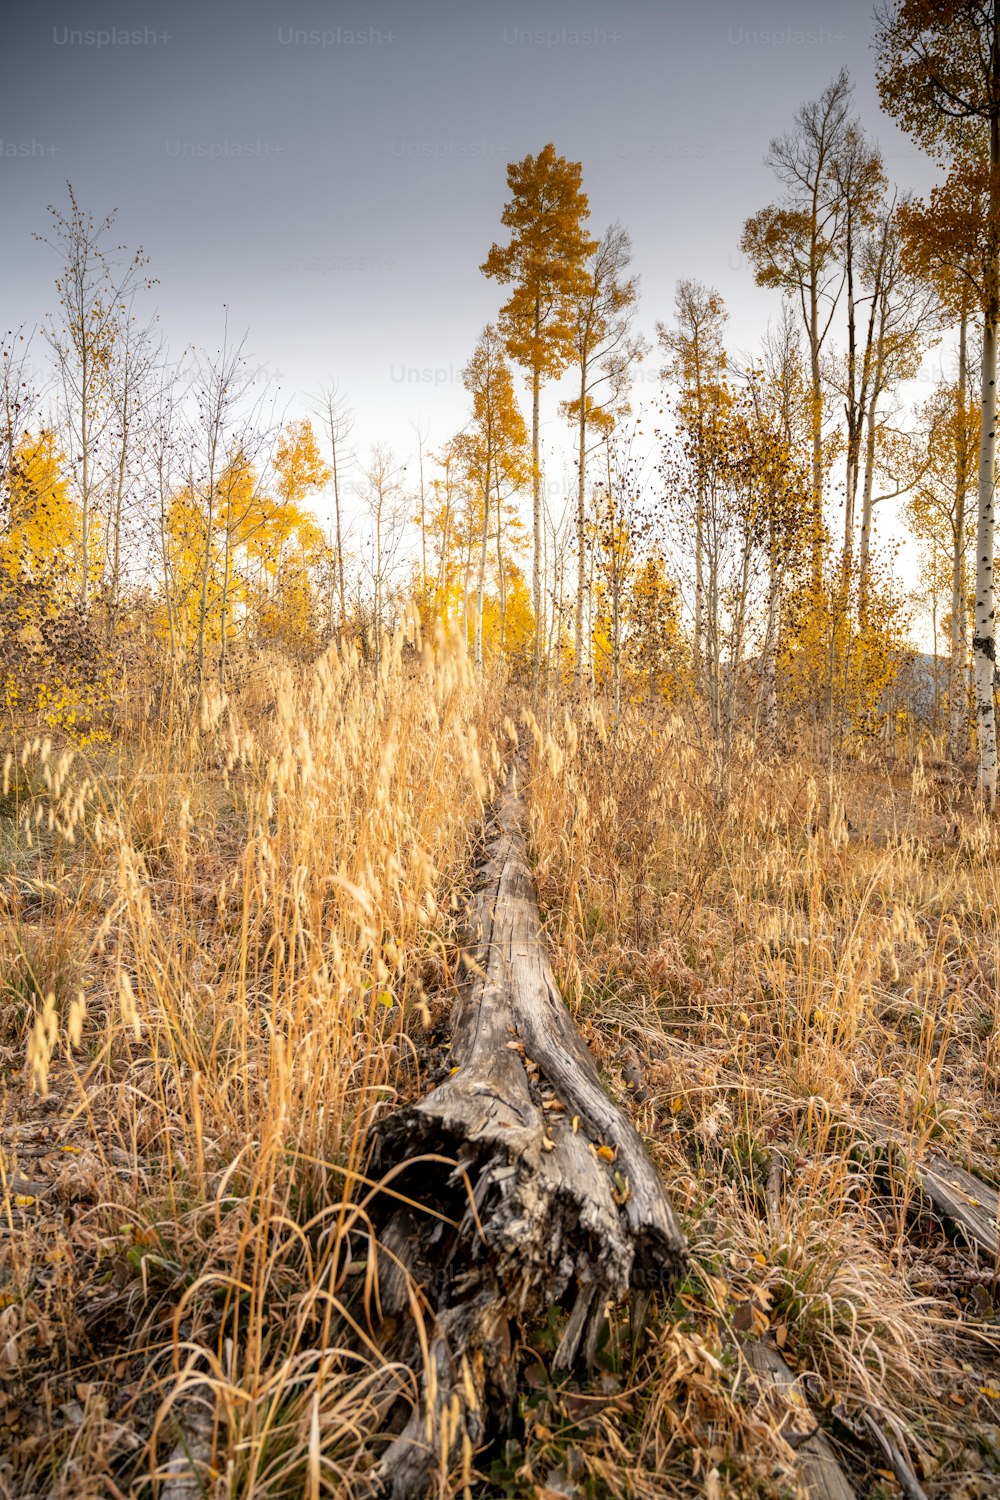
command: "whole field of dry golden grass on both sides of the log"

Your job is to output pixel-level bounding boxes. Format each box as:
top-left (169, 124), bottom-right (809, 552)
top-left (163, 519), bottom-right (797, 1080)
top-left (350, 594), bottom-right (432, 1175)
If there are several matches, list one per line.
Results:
top-left (0, 660), bottom-right (1000, 1500)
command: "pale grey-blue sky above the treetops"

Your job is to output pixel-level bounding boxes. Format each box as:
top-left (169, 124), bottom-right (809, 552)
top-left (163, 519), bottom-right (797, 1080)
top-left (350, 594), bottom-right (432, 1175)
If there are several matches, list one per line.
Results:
top-left (0, 0), bottom-right (953, 609)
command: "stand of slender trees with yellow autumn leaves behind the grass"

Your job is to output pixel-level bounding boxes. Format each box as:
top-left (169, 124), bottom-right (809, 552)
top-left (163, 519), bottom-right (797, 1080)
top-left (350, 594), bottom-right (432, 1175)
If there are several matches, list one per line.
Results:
top-left (0, 0), bottom-right (1000, 804)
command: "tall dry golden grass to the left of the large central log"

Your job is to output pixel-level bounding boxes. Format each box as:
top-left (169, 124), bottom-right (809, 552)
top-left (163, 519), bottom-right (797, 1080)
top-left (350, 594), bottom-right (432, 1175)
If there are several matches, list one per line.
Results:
top-left (0, 630), bottom-right (495, 1497)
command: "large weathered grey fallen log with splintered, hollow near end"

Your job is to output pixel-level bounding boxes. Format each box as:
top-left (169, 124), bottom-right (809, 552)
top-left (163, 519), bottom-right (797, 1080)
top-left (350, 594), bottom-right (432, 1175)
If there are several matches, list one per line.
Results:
top-left (373, 770), bottom-right (687, 1497)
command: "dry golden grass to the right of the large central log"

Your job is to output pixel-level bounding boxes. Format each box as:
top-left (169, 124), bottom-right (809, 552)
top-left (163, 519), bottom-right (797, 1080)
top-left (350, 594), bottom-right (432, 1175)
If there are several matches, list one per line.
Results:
top-left (531, 713), bottom-right (1000, 1497)
